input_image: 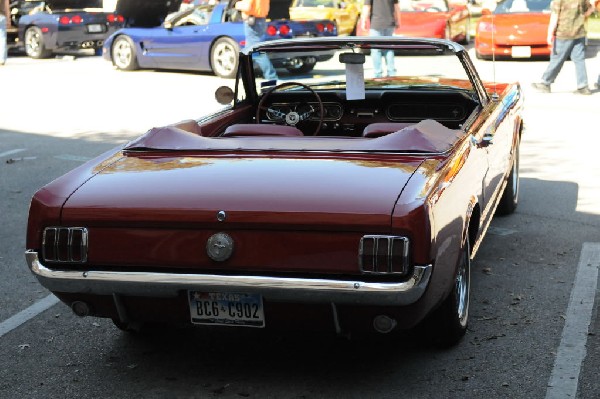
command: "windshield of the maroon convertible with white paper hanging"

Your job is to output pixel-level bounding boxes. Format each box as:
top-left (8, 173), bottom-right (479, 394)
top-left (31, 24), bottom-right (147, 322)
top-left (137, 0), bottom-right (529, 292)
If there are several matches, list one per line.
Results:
top-left (254, 46), bottom-right (474, 99)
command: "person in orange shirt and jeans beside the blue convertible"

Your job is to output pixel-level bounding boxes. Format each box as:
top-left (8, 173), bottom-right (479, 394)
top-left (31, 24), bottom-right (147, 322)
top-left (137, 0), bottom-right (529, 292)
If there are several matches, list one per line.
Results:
top-left (235, 0), bottom-right (277, 80)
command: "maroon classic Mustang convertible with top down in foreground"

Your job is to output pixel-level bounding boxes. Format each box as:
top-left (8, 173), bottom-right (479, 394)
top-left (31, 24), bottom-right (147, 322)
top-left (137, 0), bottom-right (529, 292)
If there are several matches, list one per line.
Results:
top-left (26, 37), bottom-right (523, 345)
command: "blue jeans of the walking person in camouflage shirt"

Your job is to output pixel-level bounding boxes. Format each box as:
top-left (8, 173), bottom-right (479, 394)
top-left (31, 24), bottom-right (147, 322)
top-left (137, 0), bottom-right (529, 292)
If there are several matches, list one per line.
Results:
top-left (542, 37), bottom-right (588, 89)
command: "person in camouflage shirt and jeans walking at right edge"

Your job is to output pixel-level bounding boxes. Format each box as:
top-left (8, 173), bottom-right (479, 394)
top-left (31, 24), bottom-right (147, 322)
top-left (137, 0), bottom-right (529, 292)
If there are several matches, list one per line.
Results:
top-left (532, 0), bottom-right (593, 95)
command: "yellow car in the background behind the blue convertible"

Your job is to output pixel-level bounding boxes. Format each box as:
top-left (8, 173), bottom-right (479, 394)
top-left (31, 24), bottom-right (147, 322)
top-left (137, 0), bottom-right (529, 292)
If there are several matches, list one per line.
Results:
top-left (290, 0), bottom-right (362, 35)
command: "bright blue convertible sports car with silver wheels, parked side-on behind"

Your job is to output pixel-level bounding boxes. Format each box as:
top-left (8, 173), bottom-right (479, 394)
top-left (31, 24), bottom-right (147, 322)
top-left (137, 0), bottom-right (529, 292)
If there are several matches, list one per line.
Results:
top-left (102, 0), bottom-right (337, 78)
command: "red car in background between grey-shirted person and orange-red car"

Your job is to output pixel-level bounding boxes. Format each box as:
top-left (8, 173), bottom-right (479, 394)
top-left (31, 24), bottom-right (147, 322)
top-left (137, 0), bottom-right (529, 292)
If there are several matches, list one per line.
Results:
top-left (356, 0), bottom-right (471, 44)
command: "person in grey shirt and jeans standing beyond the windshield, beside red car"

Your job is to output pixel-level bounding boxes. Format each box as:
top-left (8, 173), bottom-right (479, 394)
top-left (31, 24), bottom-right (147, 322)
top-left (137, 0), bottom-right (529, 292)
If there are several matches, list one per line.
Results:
top-left (361, 0), bottom-right (400, 78)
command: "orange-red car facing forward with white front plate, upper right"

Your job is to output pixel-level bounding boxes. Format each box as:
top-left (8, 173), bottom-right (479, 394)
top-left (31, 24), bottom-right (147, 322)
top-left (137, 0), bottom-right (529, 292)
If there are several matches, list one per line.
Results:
top-left (475, 0), bottom-right (552, 59)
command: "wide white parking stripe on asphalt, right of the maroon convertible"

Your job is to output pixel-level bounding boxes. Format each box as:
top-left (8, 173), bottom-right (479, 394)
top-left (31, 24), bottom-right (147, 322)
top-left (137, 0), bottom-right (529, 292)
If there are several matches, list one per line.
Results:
top-left (546, 242), bottom-right (600, 399)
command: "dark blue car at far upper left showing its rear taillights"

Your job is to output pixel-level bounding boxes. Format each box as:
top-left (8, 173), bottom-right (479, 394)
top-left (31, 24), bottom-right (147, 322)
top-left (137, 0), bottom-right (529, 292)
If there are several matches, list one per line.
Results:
top-left (16, 0), bottom-right (124, 58)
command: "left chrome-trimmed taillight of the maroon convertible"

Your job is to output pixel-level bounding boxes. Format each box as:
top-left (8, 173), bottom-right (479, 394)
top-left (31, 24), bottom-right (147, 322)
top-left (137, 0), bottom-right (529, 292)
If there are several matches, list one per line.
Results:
top-left (42, 227), bottom-right (88, 263)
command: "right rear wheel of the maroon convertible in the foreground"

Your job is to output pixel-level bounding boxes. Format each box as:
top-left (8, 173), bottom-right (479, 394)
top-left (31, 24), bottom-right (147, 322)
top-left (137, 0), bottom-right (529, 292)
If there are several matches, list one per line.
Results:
top-left (429, 237), bottom-right (471, 348)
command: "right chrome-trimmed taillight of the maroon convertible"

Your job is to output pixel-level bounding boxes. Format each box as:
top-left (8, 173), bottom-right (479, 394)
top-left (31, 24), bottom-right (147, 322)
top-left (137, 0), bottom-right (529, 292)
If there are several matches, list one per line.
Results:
top-left (358, 235), bottom-right (409, 275)
